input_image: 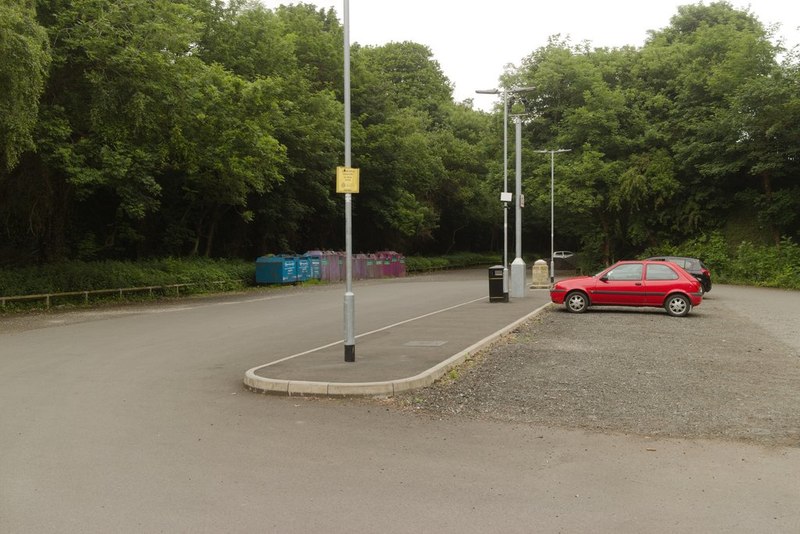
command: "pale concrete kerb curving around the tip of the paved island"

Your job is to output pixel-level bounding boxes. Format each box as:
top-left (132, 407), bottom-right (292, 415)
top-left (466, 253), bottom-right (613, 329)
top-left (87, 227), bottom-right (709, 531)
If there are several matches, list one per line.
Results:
top-left (244, 303), bottom-right (552, 397)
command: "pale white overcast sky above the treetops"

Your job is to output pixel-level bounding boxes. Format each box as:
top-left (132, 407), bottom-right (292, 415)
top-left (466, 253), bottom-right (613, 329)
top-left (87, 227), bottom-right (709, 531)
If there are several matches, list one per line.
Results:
top-left (261, 0), bottom-right (800, 110)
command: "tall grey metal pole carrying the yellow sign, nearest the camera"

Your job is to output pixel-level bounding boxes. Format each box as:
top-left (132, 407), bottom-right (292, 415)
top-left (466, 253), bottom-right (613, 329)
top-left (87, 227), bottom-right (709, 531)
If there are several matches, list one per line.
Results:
top-left (344, 0), bottom-right (356, 362)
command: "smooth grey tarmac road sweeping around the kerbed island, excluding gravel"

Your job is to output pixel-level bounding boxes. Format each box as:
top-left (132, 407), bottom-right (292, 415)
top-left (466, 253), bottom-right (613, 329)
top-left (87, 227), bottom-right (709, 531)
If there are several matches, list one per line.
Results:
top-left (0, 271), bottom-right (800, 533)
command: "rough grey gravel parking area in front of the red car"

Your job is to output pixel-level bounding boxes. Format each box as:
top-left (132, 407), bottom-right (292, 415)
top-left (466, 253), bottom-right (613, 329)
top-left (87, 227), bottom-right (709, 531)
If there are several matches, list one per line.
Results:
top-left (390, 287), bottom-right (800, 446)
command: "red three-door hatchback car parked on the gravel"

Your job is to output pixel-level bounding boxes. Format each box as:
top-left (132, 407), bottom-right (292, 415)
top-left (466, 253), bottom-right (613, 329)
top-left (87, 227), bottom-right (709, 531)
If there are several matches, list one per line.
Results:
top-left (550, 260), bottom-right (703, 317)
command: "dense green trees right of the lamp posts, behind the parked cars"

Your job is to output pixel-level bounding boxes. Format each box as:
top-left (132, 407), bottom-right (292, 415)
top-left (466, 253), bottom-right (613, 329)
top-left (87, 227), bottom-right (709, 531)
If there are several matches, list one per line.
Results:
top-left (506, 2), bottom-right (800, 262)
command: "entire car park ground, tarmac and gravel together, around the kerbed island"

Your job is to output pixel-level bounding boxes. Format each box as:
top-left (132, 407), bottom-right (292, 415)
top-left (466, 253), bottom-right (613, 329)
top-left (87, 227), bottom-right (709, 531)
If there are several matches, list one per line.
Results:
top-left (0, 270), bottom-right (800, 534)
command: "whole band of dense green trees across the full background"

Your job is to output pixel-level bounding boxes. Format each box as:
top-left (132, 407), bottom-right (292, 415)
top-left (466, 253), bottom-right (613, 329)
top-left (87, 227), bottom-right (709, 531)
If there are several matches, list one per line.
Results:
top-left (0, 0), bottom-right (800, 265)
